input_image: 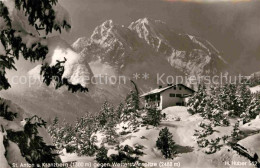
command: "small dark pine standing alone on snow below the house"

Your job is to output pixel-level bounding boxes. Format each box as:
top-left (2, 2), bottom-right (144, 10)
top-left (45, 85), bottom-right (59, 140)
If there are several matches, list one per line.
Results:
top-left (156, 127), bottom-right (176, 158)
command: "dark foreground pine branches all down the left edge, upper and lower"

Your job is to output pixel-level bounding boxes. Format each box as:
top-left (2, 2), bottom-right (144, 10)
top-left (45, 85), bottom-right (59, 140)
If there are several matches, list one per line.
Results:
top-left (0, 0), bottom-right (87, 165)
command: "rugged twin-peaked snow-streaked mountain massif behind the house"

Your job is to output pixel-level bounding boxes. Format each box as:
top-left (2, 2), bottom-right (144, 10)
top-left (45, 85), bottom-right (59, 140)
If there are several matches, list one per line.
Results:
top-left (72, 18), bottom-right (227, 82)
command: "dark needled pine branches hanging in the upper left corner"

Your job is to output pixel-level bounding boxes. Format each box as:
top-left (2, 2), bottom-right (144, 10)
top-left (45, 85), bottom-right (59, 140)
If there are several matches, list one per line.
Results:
top-left (0, 0), bottom-right (84, 92)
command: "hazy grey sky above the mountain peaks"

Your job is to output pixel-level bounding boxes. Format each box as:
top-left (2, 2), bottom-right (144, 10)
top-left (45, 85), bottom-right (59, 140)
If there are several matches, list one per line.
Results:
top-left (59, 0), bottom-right (260, 74)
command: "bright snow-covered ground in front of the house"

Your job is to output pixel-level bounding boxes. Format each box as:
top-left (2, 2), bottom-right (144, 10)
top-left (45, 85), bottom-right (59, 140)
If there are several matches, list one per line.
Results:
top-left (61, 107), bottom-right (260, 168)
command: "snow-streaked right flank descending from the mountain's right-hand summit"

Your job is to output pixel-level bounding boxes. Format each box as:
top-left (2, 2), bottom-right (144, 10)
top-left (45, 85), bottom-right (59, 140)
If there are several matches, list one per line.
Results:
top-left (129, 18), bottom-right (227, 76)
